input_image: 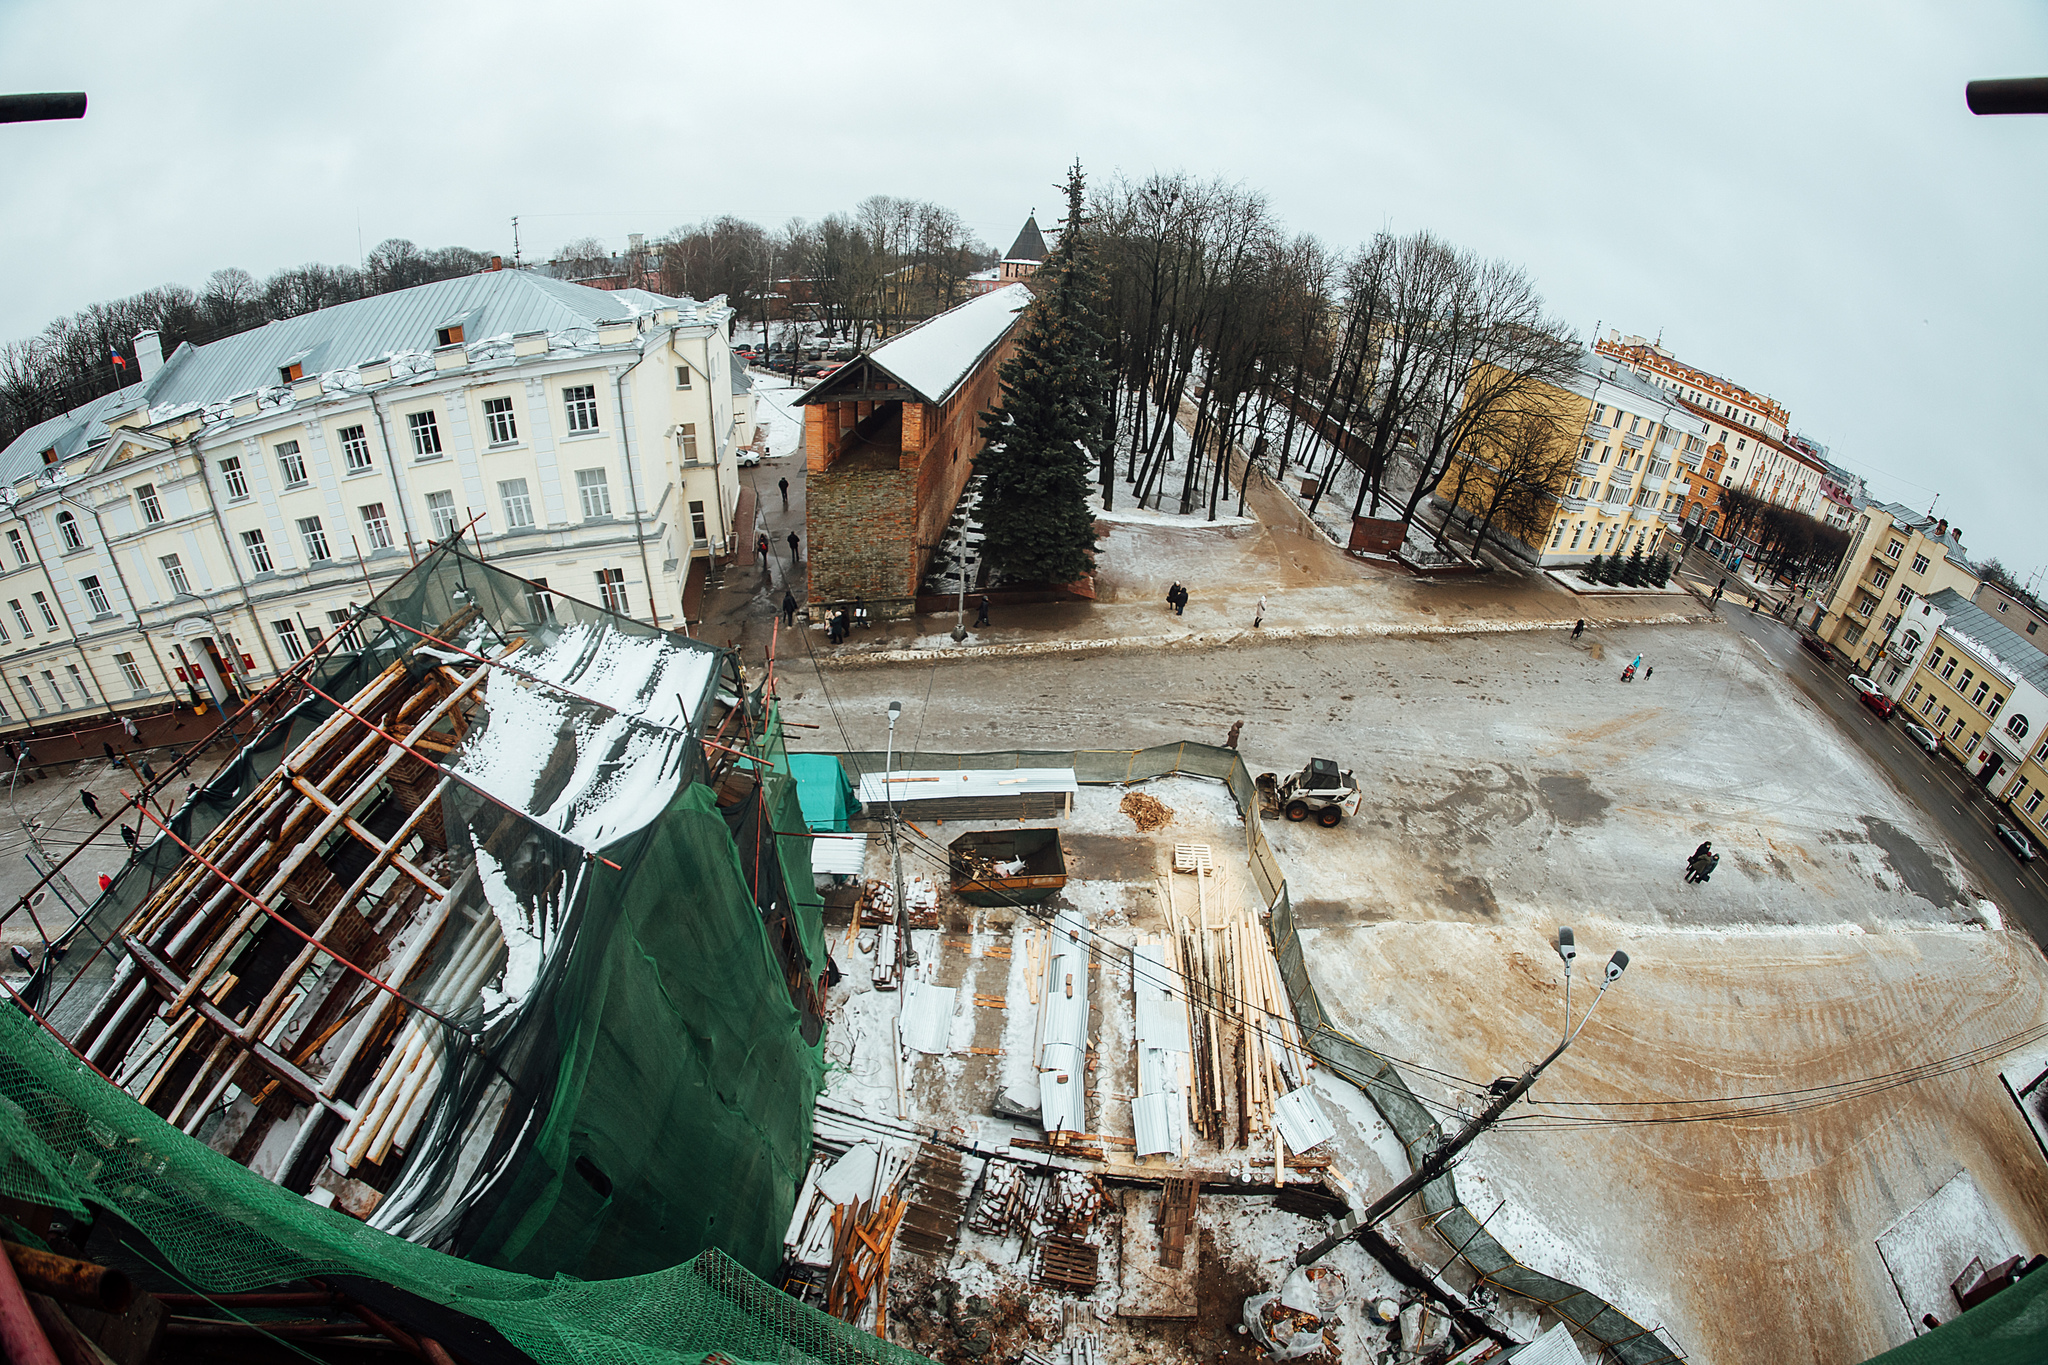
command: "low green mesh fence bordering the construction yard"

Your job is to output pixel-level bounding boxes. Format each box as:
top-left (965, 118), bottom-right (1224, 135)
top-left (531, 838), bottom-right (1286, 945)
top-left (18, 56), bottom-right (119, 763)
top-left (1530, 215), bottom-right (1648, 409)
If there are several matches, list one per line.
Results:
top-left (806, 741), bottom-right (1686, 1365)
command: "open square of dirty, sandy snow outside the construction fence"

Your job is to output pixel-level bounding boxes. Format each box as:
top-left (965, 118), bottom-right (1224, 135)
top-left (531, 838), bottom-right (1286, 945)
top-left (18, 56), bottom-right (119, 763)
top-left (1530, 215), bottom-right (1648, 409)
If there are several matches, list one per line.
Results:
top-left (782, 620), bottom-right (2048, 1361)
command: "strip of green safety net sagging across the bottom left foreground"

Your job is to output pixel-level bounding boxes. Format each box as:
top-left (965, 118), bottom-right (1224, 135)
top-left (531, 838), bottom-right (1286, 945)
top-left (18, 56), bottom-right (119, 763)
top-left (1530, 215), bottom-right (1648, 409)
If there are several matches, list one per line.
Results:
top-left (0, 1009), bottom-right (920, 1365)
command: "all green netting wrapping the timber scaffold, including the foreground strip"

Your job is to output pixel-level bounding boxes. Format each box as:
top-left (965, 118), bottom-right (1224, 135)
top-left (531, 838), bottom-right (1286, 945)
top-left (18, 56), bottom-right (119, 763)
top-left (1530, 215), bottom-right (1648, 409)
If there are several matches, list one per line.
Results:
top-left (0, 548), bottom-right (913, 1359)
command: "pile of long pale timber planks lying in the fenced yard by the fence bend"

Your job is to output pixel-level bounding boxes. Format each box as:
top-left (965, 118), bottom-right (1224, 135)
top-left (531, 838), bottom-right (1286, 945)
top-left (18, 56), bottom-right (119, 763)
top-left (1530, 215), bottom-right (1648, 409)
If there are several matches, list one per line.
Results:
top-left (1167, 843), bottom-right (1309, 1181)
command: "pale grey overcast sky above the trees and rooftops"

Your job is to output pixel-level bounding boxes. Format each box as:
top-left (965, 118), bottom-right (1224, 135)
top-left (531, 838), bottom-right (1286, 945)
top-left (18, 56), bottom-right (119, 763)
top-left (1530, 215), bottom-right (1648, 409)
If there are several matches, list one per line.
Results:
top-left (0, 0), bottom-right (2048, 579)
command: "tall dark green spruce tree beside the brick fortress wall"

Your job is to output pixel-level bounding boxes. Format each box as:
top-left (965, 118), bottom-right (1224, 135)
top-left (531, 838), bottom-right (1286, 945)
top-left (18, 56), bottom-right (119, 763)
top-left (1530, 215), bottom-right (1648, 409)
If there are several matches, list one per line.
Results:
top-left (975, 162), bottom-right (1110, 583)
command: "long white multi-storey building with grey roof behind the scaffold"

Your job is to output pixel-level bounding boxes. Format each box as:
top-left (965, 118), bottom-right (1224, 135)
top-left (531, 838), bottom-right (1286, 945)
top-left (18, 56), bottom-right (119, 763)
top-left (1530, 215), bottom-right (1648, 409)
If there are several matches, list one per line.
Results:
top-left (0, 270), bottom-right (754, 729)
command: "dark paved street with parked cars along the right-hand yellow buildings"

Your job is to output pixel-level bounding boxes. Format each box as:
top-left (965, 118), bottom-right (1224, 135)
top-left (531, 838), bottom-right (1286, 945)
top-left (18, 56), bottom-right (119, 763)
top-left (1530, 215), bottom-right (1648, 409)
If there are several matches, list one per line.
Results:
top-left (1720, 602), bottom-right (2048, 948)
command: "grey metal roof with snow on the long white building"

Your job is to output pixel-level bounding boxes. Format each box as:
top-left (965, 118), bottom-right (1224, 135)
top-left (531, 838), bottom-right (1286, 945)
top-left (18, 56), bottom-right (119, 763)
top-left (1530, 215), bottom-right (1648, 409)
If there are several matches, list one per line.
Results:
top-left (0, 270), bottom-right (725, 483)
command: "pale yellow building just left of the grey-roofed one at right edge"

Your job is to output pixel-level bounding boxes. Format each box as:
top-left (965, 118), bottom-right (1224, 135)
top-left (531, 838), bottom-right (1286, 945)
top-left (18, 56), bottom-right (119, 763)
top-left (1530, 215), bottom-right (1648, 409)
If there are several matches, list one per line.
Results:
top-left (1812, 503), bottom-right (1978, 671)
